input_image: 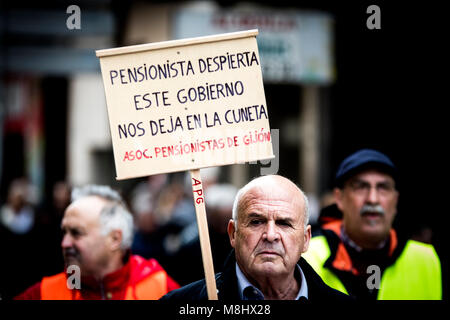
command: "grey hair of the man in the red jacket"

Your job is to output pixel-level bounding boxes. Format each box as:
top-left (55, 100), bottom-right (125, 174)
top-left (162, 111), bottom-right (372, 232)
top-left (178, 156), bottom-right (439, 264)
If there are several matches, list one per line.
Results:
top-left (72, 185), bottom-right (134, 250)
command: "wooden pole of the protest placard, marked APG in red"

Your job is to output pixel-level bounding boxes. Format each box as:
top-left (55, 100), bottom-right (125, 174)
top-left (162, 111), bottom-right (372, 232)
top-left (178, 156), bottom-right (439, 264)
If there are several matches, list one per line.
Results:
top-left (190, 169), bottom-right (218, 300)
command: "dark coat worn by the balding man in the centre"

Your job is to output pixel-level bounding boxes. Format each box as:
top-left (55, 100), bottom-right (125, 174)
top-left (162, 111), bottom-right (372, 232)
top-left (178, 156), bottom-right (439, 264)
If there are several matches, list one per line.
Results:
top-left (161, 250), bottom-right (353, 302)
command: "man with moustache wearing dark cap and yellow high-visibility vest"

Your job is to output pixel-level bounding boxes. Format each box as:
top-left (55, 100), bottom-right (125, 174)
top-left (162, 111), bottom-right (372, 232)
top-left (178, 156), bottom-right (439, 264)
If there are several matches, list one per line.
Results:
top-left (303, 149), bottom-right (442, 300)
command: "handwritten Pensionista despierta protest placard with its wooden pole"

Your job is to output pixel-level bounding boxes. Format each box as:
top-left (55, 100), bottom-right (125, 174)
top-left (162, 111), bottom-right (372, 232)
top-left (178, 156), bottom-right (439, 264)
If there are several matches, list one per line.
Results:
top-left (96, 30), bottom-right (274, 300)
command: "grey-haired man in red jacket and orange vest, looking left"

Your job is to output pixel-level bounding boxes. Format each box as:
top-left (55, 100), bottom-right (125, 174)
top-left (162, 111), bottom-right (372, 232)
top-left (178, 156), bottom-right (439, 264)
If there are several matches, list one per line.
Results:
top-left (16, 185), bottom-right (179, 300)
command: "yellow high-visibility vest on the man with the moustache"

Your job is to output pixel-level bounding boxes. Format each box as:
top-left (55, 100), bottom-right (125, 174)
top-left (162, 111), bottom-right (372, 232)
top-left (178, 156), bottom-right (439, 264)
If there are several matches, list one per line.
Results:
top-left (302, 236), bottom-right (442, 300)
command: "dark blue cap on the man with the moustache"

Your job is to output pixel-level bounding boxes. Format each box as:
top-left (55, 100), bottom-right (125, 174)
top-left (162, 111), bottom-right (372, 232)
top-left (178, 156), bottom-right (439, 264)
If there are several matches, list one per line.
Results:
top-left (335, 149), bottom-right (397, 188)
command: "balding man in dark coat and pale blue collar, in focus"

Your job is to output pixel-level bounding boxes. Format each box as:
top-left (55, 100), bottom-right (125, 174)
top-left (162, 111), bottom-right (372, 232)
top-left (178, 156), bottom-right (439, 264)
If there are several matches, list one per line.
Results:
top-left (161, 175), bottom-right (351, 301)
